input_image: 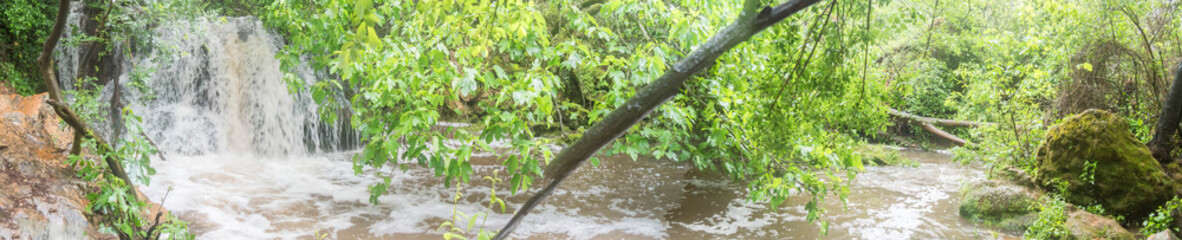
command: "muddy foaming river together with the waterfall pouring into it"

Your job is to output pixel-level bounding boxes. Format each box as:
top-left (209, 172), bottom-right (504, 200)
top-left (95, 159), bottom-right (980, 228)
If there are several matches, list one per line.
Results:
top-left (59, 15), bottom-right (1007, 239)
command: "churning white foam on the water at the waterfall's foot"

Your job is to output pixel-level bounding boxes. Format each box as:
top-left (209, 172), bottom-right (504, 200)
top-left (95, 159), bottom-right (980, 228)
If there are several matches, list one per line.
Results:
top-left (143, 155), bottom-right (381, 239)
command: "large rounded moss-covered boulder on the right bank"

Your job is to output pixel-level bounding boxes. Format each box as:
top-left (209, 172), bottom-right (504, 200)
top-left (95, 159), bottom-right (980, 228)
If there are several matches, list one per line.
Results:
top-left (1034, 110), bottom-right (1175, 219)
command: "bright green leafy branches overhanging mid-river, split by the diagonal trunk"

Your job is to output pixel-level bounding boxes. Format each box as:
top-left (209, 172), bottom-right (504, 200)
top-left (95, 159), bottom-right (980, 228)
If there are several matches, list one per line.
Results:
top-left (261, 0), bottom-right (885, 235)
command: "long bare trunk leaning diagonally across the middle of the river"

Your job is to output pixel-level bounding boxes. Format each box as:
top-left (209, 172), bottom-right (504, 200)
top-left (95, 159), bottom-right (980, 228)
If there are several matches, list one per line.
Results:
top-left (493, 0), bottom-right (819, 240)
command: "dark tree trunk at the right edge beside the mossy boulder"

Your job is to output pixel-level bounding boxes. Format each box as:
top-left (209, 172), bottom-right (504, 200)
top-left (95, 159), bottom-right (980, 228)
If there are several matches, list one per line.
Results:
top-left (1148, 63), bottom-right (1182, 163)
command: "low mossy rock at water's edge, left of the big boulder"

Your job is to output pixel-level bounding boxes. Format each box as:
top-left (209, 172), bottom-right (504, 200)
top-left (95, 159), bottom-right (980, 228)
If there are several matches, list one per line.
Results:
top-left (960, 181), bottom-right (1039, 233)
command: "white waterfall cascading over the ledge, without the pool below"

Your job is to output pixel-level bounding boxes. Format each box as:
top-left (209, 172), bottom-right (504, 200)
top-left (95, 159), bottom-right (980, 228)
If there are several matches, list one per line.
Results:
top-left (58, 15), bottom-right (357, 156)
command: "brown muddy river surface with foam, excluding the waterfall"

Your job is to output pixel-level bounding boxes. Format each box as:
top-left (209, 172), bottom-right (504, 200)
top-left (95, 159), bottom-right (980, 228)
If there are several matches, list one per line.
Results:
top-left (135, 150), bottom-right (995, 239)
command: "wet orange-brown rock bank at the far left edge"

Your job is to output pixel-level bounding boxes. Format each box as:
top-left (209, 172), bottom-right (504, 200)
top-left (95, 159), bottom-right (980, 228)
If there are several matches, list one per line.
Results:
top-left (0, 84), bottom-right (111, 239)
